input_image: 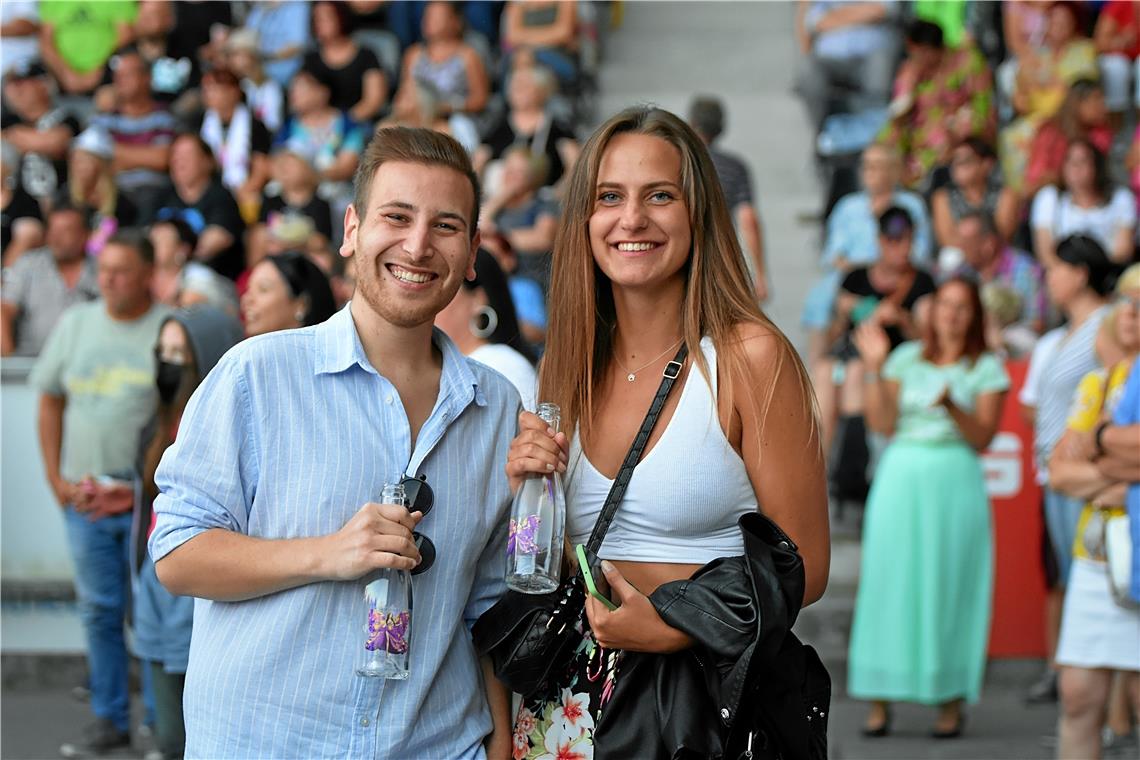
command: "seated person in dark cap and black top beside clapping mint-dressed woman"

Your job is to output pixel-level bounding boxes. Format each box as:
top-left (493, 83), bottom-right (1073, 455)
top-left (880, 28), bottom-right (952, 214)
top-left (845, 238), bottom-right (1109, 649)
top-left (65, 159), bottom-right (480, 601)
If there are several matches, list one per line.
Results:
top-left (814, 206), bottom-right (935, 451)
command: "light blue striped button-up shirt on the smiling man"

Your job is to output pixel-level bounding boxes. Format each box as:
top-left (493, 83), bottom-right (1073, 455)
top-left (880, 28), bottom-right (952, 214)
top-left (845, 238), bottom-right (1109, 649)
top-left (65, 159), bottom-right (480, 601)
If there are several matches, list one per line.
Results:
top-left (150, 308), bottom-right (520, 758)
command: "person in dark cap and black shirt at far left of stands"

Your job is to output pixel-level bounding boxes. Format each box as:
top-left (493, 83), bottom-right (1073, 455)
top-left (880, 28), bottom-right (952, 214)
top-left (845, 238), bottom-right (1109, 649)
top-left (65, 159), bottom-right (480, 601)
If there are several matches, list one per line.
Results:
top-left (0, 60), bottom-right (79, 204)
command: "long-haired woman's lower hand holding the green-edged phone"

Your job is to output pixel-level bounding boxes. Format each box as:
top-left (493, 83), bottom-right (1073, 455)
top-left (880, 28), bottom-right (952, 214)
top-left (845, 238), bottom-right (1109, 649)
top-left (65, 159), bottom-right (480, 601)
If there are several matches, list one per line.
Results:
top-left (586, 561), bottom-right (693, 654)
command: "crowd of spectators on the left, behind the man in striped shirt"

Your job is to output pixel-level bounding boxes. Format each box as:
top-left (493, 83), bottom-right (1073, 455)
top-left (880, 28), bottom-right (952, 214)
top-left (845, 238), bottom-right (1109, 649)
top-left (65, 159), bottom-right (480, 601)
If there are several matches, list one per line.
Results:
top-left (0, 0), bottom-right (609, 758)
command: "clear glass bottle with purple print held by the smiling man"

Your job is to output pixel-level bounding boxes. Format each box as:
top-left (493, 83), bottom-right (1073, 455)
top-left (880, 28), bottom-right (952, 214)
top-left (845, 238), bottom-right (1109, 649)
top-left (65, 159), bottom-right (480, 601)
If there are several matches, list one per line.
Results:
top-left (356, 483), bottom-right (412, 680)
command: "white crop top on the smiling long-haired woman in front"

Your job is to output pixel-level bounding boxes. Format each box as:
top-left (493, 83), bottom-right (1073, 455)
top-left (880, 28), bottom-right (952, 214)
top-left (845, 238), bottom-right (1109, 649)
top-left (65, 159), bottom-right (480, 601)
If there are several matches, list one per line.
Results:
top-left (564, 337), bottom-right (757, 564)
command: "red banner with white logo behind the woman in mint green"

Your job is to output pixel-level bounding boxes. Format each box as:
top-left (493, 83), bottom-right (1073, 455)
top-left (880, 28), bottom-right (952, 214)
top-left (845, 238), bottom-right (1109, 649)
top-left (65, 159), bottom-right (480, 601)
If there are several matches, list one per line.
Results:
top-left (983, 361), bottom-right (1045, 657)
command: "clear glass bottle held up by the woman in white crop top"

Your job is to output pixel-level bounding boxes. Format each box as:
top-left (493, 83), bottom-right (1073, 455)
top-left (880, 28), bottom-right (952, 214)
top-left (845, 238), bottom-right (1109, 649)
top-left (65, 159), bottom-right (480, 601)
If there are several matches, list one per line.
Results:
top-left (506, 403), bottom-right (567, 594)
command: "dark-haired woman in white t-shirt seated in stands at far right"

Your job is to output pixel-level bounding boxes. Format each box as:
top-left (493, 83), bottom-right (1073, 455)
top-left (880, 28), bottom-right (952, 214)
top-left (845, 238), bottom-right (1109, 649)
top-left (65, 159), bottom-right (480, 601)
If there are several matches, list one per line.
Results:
top-left (1029, 138), bottom-right (1137, 267)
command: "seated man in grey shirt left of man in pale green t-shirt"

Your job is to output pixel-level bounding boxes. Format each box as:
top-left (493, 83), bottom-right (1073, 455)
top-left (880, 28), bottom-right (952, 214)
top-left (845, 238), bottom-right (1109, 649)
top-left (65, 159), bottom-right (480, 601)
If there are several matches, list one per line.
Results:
top-left (0, 205), bottom-right (99, 357)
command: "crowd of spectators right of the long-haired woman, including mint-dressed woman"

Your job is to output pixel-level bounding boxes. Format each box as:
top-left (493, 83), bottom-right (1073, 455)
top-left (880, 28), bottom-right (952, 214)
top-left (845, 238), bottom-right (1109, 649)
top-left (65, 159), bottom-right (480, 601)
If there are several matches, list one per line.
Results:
top-left (796, 0), bottom-right (1140, 757)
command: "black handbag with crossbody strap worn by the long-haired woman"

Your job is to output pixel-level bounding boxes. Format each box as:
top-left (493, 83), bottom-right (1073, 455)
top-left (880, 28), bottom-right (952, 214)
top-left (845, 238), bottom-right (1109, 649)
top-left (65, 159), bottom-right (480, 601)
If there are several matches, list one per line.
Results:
top-left (471, 344), bottom-right (689, 697)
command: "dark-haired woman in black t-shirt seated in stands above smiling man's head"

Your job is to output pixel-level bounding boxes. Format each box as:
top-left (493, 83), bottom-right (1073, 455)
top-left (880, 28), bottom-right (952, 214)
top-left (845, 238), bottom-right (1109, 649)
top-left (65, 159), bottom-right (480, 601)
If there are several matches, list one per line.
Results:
top-left (302, 1), bottom-right (388, 124)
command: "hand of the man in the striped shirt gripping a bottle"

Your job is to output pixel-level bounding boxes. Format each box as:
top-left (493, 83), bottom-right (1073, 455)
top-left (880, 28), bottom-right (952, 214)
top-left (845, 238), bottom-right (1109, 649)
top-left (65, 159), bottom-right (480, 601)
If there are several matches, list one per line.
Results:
top-left (320, 501), bottom-right (423, 581)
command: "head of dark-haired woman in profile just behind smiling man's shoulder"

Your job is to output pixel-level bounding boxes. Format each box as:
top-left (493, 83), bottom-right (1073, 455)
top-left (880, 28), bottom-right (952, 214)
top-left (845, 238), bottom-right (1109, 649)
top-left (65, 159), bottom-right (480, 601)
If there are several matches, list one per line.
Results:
top-left (242, 253), bottom-right (336, 336)
